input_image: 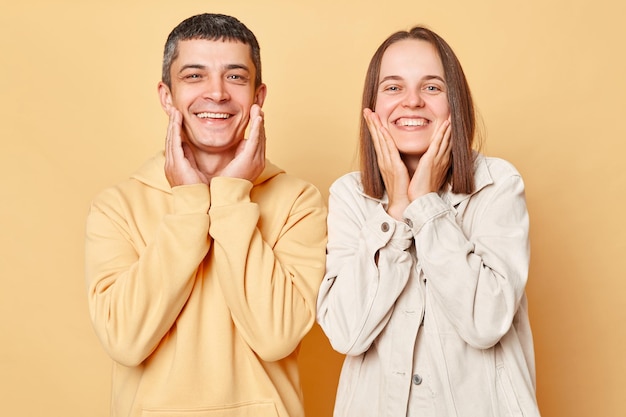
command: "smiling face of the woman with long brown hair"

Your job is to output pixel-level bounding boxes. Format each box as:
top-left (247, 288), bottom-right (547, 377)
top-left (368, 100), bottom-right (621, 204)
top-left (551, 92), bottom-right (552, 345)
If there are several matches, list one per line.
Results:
top-left (374, 39), bottom-right (450, 158)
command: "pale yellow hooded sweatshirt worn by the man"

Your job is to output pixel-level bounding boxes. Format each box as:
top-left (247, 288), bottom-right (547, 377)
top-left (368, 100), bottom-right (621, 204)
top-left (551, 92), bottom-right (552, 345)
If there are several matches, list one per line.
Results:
top-left (85, 152), bottom-right (326, 417)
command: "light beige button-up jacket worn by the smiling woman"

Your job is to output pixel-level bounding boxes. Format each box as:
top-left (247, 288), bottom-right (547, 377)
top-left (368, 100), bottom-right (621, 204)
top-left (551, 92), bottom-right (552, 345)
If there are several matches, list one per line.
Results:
top-left (317, 155), bottom-right (539, 417)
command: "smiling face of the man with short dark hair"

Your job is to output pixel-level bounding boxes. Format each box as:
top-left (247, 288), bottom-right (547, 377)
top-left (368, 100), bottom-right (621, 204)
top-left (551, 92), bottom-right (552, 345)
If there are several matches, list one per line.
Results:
top-left (159, 39), bottom-right (266, 153)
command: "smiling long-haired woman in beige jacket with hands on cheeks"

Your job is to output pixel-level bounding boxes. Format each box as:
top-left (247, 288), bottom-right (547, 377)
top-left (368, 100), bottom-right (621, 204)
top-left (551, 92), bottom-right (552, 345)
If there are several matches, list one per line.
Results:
top-left (317, 27), bottom-right (539, 417)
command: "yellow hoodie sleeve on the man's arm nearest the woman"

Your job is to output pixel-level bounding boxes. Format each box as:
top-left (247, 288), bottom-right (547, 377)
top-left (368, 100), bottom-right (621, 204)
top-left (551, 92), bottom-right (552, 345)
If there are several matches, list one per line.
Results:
top-left (209, 177), bottom-right (326, 361)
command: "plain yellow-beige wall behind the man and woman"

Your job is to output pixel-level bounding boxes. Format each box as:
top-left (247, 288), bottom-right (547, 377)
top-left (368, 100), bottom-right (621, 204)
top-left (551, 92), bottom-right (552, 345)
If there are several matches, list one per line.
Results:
top-left (0, 0), bottom-right (626, 417)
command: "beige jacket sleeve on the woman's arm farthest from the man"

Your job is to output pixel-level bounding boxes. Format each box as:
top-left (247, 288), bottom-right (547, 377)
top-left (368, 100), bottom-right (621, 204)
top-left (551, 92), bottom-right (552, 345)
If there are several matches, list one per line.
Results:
top-left (405, 170), bottom-right (530, 349)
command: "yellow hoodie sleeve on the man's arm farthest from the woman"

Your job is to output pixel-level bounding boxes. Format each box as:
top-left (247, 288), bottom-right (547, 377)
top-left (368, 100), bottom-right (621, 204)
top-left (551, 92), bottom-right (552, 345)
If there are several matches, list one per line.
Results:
top-left (85, 184), bottom-right (210, 366)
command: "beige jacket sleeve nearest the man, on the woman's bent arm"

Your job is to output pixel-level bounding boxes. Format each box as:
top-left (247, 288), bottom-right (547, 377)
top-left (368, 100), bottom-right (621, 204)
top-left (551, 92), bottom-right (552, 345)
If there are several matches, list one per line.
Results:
top-left (317, 176), bottom-right (413, 355)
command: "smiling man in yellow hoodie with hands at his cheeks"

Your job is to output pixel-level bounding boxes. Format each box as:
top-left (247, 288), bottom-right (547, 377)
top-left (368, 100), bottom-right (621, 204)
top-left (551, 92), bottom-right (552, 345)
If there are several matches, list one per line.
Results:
top-left (86, 14), bottom-right (326, 417)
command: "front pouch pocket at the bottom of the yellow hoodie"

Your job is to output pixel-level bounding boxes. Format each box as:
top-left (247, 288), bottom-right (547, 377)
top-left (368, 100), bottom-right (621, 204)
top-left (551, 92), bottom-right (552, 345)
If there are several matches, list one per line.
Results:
top-left (141, 401), bottom-right (278, 417)
